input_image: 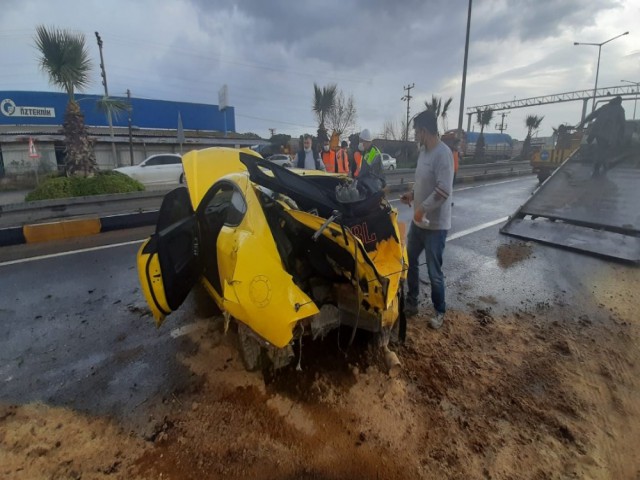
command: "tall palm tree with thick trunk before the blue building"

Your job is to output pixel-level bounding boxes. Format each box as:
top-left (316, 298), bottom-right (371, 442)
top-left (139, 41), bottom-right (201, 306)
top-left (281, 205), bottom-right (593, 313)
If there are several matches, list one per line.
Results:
top-left (35, 25), bottom-right (97, 177)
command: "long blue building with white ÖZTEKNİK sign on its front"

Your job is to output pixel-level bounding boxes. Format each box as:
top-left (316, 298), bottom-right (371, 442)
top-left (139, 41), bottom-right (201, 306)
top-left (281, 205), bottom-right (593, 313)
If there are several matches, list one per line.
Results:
top-left (0, 91), bottom-right (266, 177)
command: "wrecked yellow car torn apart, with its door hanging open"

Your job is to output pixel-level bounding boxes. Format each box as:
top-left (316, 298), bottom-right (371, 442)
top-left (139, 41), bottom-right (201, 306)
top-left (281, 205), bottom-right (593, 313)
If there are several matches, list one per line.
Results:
top-left (137, 148), bottom-right (406, 369)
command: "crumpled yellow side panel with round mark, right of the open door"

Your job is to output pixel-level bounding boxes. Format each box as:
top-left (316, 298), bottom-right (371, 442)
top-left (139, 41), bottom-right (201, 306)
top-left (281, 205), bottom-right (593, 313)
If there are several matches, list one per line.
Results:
top-left (197, 174), bottom-right (318, 347)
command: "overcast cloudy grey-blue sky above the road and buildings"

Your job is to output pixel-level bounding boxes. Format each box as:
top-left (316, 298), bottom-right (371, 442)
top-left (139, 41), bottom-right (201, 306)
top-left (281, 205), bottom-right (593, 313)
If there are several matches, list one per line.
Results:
top-left (0, 0), bottom-right (640, 139)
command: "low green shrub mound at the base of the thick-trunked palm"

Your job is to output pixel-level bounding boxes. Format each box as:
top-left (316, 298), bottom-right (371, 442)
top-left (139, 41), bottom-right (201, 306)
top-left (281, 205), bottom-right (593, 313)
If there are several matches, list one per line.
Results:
top-left (25, 172), bottom-right (144, 202)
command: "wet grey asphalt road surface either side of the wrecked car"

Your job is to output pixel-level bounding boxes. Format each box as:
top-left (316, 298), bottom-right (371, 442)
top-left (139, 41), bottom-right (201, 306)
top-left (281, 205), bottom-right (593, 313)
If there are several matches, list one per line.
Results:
top-left (0, 176), bottom-right (633, 426)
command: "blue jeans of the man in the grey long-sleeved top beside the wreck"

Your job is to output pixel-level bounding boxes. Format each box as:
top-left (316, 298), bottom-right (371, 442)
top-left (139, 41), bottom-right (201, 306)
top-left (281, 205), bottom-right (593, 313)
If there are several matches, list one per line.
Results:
top-left (407, 222), bottom-right (447, 313)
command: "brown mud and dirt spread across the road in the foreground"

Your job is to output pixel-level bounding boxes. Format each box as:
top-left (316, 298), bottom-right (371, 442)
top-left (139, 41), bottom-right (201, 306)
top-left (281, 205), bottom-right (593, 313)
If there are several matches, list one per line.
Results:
top-left (0, 264), bottom-right (640, 480)
